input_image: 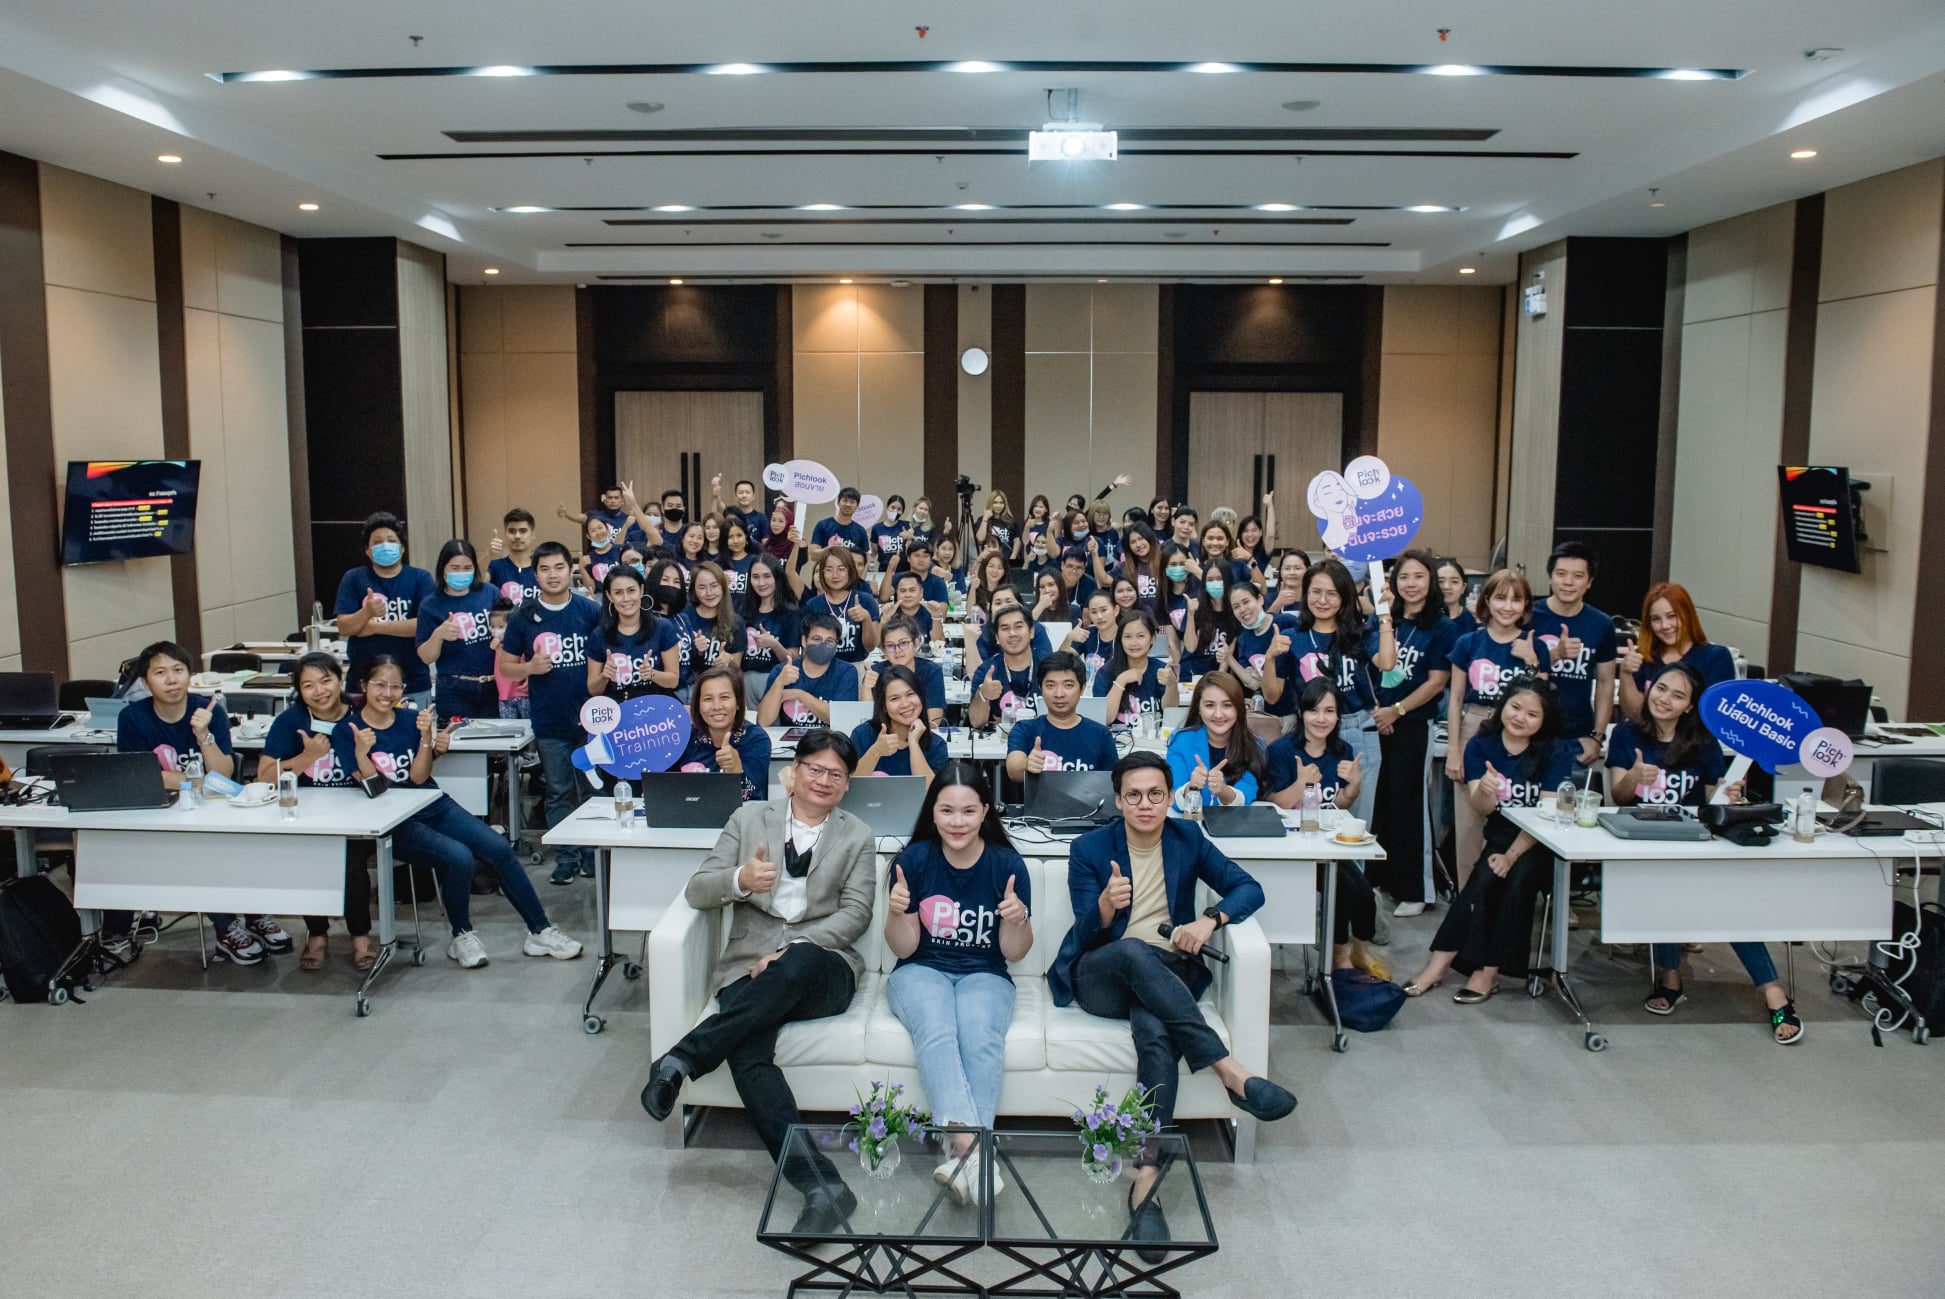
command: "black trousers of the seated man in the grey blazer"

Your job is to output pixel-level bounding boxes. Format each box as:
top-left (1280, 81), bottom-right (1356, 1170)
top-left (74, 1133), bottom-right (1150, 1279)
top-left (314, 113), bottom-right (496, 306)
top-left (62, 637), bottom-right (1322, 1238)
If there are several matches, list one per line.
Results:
top-left (673, 943), bottom-right (858, 1194)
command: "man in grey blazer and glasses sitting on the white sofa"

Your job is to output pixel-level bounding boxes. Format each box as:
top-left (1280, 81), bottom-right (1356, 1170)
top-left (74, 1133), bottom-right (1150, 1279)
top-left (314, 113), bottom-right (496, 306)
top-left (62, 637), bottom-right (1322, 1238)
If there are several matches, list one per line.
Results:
top-left (642, 729), bottom-right (877, 1231)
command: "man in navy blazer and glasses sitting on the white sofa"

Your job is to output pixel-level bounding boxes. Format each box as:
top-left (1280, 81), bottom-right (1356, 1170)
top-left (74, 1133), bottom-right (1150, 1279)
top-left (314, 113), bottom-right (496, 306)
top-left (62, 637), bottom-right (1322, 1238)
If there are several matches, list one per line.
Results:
top-left (1046, 753), bottom-right (1297, 1262)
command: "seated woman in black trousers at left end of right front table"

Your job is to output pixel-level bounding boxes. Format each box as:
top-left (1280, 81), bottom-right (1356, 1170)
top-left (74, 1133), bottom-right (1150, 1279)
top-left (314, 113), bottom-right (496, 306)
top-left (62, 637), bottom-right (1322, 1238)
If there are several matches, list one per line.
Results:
top-left (1404, 677), bottom-right (1579, 1005)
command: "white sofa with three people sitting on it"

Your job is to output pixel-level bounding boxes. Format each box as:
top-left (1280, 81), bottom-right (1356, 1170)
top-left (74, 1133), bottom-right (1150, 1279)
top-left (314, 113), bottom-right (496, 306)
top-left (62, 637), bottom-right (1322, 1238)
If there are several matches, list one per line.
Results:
top-left (648, 852), bottom-right (1270, 1161)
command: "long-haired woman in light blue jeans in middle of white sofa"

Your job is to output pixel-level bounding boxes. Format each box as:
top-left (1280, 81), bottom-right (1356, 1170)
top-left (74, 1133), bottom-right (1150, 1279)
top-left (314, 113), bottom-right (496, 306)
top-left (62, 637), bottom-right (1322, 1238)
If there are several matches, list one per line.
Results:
top-left (885, 760), bottom-right (1033, 1204)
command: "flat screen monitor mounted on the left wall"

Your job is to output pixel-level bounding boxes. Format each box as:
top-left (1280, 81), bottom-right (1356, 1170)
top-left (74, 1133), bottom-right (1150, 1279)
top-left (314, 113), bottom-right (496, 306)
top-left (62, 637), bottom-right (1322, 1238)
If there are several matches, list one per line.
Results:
top-left (60, 461), bottom-right (202, 564)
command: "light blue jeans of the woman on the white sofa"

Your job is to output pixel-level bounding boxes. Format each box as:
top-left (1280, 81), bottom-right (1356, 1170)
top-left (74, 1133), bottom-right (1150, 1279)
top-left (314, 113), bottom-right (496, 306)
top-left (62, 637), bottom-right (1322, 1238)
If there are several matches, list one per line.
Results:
top-left (885, 965), bottom-right (1013, 1128)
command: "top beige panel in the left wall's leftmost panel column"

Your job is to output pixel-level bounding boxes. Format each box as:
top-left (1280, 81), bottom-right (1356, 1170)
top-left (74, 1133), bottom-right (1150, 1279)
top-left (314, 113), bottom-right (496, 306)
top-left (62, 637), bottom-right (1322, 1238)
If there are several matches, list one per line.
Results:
top-left (41, 163), bottom-right (156, 301)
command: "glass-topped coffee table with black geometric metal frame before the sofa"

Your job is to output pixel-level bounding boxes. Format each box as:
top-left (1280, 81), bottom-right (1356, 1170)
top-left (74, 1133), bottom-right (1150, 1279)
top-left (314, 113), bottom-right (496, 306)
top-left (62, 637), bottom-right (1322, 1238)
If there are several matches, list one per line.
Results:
top-left (757, 1124), bottom-right (1218, 1297)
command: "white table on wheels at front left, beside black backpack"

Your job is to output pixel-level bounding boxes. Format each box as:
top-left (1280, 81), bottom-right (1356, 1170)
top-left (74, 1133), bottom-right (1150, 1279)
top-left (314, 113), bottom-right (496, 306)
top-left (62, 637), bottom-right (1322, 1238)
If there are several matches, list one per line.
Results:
top-left (0, 788), bottom-right (440, 1017)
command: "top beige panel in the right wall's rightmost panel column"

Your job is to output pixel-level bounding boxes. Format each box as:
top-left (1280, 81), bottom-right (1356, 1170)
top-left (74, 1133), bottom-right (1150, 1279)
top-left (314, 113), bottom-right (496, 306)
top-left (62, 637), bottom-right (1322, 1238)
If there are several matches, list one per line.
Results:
top-left (1817, 158), bottom-right (1945, 305)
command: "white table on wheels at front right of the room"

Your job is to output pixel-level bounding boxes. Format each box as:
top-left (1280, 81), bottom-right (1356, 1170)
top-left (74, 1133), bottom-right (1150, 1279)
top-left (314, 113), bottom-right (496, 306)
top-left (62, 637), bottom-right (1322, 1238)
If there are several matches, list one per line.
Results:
top-left (1505, 807), bottom-right (1941, 1050)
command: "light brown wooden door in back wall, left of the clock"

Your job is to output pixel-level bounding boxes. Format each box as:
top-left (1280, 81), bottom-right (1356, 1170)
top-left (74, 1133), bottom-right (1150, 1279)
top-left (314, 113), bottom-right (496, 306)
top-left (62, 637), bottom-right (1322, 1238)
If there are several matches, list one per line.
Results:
top-left (615, 393), bottom-right (762, 517)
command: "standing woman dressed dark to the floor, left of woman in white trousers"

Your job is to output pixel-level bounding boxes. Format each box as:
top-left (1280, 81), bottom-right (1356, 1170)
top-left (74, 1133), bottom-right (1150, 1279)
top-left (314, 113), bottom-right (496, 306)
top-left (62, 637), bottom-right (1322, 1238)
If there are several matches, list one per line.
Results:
top-left (1367, 550), bottom-right (1453, 916)
